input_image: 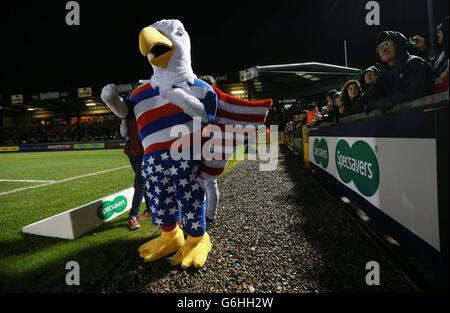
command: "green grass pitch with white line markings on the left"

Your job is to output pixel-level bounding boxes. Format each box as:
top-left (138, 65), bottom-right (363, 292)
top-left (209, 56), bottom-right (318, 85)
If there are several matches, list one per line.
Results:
top-left (0, 150), bottom-right (243, 292)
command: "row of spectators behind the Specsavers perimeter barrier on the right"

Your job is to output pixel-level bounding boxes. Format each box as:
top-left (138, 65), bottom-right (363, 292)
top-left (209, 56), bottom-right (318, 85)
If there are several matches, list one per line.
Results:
top-left (285, 16), bottom-right (449, 132)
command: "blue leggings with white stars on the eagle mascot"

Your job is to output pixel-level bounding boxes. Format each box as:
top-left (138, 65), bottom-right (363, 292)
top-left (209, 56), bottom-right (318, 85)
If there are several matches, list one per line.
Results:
top-left (142, 152), bottom-right (206, 237)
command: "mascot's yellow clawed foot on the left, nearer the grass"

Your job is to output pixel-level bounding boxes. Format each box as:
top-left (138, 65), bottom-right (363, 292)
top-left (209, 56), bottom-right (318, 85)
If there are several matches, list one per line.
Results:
top-left (138, 225), bottom-right (184, 262)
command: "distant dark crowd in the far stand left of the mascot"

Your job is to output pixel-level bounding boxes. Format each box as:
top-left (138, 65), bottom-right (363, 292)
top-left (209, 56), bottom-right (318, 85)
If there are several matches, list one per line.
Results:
top-left (2, 118), bottom-right (121, 145)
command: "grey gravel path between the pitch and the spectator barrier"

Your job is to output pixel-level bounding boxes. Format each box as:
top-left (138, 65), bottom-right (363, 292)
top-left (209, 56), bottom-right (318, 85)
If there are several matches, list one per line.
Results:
top-left (100, 146), bottom-right (414, 293)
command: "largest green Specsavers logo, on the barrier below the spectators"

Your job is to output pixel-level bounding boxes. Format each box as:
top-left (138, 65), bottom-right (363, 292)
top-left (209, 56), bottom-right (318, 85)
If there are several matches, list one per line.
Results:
top-left (336, 140), bottom-right (380, 197)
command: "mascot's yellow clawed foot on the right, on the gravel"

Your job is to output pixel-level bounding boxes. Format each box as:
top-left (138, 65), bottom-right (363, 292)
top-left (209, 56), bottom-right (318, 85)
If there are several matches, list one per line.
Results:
top-left (170, 233), bottom-right (212, 269)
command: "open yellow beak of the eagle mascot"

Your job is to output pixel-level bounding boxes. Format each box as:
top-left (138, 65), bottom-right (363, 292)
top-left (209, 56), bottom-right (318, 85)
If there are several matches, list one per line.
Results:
top-left (139, 26), bottom-right (175, 68)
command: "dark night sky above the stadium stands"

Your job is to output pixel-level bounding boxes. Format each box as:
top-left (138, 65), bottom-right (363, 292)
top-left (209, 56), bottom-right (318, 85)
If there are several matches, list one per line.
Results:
top-left (0, 0), bottom-right (448, 94)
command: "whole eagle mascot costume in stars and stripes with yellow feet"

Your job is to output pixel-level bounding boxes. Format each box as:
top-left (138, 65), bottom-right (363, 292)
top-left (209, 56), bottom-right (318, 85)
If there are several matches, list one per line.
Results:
top-left (101, 20), bottom-right (272, 269)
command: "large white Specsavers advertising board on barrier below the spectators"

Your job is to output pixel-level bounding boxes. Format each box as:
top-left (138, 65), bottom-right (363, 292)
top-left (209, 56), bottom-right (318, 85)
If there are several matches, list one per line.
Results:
top-left (309, 136), bottom-right (440, 251)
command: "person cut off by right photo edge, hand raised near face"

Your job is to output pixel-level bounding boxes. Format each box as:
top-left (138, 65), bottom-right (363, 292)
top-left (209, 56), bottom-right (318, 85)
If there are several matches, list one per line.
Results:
top-left (413, 16), bottom-right (449, 93)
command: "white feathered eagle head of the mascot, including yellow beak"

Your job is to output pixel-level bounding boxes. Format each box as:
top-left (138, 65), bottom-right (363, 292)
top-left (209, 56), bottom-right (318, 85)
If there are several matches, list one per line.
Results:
top-left (139, 20), bottom-right (196, 95)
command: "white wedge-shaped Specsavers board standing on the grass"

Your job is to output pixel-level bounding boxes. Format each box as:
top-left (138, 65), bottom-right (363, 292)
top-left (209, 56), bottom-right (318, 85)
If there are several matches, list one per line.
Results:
top-left (22, 187), bottom-right (134, 239)
